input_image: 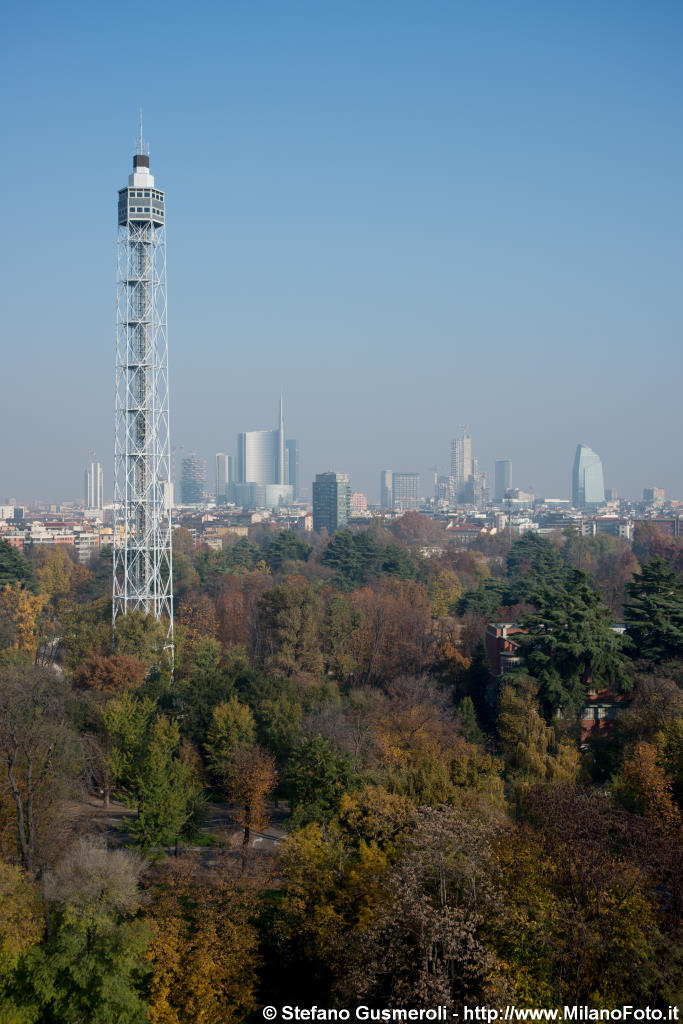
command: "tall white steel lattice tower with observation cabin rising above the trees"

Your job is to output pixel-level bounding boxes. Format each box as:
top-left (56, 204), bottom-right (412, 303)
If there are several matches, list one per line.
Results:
top-left (112, 128), bottom-right (173, 652)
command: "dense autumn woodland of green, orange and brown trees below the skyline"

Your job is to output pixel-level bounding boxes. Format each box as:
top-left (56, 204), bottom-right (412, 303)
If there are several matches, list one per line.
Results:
top-left (0, 513), bottom-right (683, 1024)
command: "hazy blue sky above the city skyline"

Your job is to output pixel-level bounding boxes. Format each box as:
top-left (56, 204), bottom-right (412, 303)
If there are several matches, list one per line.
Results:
top-left (0, 0), bottom-right (683, 501)
